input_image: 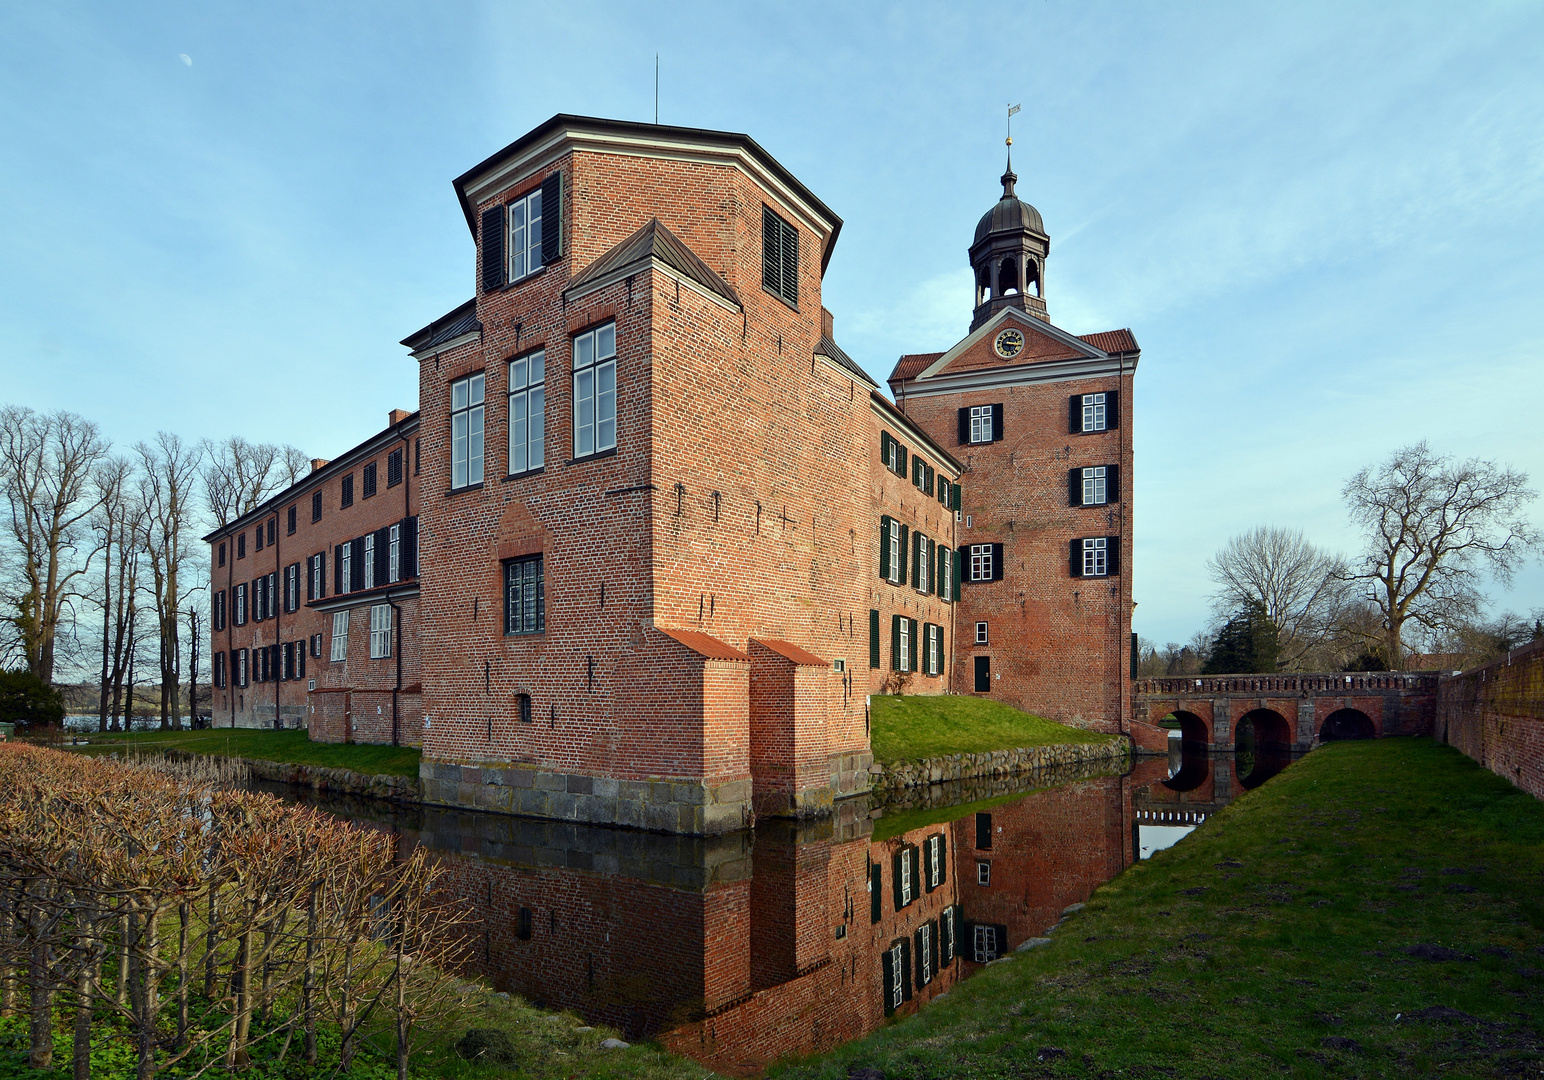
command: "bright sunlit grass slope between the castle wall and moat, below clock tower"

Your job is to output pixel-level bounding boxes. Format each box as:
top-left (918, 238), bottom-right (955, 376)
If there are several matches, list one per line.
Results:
top-left (869, 694), bottom-right (1113, 762)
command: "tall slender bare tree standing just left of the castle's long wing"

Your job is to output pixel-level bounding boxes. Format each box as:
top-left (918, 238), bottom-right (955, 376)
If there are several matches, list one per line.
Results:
top-left (134, 431), bottom-right (204, 729)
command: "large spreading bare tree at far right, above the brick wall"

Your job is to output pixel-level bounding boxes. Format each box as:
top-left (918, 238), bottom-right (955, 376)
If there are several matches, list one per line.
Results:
top-left (1342, 442), bottom-right (1539, 671)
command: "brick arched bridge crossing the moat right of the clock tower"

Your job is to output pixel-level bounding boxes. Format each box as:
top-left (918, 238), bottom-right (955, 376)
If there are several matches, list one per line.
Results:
top-left (1132, 672), bottom-right (1437, 751)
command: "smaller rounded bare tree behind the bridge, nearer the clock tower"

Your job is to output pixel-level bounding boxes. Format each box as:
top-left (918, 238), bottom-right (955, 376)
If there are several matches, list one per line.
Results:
top-left (1206, 525), bottom-right (1346, 671)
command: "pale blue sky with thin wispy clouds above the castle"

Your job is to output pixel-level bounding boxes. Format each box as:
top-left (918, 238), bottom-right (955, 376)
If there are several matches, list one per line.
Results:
top-left (0, 0), bottom-right (1544, 643)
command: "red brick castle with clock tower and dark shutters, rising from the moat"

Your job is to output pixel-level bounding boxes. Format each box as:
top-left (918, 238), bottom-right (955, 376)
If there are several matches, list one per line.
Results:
top-left (207, 116), bottom-right (1138, 834)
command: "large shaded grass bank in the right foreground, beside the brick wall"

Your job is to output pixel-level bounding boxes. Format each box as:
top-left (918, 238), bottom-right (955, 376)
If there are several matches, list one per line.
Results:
top-left (775, 739), bottom-right (1544, 1080)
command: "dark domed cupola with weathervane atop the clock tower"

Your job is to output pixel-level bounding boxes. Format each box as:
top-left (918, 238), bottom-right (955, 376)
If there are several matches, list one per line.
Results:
top-left (970, 136), bottom-right (1051, 329)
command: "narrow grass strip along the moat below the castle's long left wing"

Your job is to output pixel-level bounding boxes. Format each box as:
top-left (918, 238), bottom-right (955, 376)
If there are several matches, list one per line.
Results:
top-left (65, 728), bottom-right (422, 776)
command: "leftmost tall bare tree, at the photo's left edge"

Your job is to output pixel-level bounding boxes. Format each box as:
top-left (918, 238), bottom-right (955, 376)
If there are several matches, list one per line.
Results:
top-left (0, 405), bottom-right (108, 684)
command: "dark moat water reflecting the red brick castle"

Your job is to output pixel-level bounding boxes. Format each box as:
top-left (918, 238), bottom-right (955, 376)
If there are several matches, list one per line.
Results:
top-left (262, 754), bottom-right (1290, 1075)
